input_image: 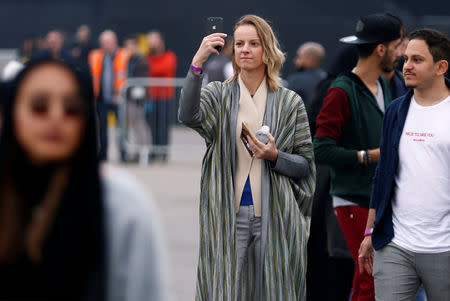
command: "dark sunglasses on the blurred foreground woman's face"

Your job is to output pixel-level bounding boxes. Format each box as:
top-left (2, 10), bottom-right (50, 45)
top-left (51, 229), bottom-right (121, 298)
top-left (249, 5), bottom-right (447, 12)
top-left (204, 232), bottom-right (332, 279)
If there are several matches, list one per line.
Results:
top-left (30, 97), bottom-right (86, 118)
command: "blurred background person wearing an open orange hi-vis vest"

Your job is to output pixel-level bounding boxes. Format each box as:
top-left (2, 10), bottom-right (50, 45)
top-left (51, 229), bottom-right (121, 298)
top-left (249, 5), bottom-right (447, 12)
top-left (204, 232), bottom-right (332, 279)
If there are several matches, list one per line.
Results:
top-left (89, 30), bottom-right (128, 160)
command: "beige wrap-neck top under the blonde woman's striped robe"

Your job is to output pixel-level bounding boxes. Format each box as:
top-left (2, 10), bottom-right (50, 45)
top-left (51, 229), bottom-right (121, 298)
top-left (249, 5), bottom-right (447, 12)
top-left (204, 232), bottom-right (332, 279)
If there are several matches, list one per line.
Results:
top-left (234, 76), bottom-right (267, 216)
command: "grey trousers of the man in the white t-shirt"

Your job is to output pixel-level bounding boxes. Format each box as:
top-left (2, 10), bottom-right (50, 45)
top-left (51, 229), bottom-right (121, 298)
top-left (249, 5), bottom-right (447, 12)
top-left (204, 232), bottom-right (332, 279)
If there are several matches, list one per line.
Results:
top-left (373, 242), bottom-right (450, 301)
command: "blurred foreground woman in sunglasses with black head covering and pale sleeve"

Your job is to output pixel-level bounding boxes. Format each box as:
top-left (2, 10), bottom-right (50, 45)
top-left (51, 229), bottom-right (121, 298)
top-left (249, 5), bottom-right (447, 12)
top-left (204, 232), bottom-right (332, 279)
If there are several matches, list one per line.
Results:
top-left (0, 59), bottom-right (165, 300)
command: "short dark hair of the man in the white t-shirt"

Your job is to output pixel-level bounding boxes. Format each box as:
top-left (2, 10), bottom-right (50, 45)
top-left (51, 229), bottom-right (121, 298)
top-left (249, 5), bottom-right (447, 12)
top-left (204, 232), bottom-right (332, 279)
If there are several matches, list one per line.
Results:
top-left (408, 28), bottom-right (450, 63)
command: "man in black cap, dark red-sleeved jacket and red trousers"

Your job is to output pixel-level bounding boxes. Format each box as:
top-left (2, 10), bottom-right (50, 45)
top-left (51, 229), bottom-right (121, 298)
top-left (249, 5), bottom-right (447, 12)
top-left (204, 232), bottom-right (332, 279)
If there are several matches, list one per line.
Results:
top-left (314, 14), bottom-right (401, 301)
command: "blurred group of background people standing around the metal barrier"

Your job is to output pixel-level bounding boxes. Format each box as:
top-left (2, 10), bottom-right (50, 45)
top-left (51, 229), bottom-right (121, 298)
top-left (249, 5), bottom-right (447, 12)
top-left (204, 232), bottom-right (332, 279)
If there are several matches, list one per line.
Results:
top-left (13, 25), bottom-right (177, 162)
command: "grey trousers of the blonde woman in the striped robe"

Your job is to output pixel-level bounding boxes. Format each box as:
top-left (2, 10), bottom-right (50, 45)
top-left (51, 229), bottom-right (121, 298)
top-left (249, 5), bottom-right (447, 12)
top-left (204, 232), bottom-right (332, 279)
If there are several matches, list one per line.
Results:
top-left (236, 206), bottom-right (261, 279)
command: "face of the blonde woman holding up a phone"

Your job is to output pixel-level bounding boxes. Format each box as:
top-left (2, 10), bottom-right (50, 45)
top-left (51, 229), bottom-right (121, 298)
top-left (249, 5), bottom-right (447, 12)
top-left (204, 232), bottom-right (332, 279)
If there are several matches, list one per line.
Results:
top-left (234, 25), bottom-right (266, 71)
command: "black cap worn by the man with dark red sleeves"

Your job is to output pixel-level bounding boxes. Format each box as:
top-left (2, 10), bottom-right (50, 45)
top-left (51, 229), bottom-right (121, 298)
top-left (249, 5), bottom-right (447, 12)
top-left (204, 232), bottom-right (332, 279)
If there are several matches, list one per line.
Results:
top-left (339, 14), bottom-right (401, 44)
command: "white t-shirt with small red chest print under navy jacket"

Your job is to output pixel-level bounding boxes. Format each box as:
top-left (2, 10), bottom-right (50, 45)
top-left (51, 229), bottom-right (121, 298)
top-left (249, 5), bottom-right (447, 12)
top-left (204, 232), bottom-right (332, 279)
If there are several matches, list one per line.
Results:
top-left (392, 96), bottom-right (450, 253)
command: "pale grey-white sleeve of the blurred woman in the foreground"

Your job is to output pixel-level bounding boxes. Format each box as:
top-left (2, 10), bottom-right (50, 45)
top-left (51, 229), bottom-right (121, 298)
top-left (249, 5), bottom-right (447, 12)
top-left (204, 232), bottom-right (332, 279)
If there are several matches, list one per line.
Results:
top-left (103, 165), bottom-right (170, 301)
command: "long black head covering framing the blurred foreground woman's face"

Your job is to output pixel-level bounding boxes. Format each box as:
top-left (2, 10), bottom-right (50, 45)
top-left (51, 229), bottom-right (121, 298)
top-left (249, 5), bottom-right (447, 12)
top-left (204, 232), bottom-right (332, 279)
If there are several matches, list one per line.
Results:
top-left (0, 58), bottom-right (105, 300)
